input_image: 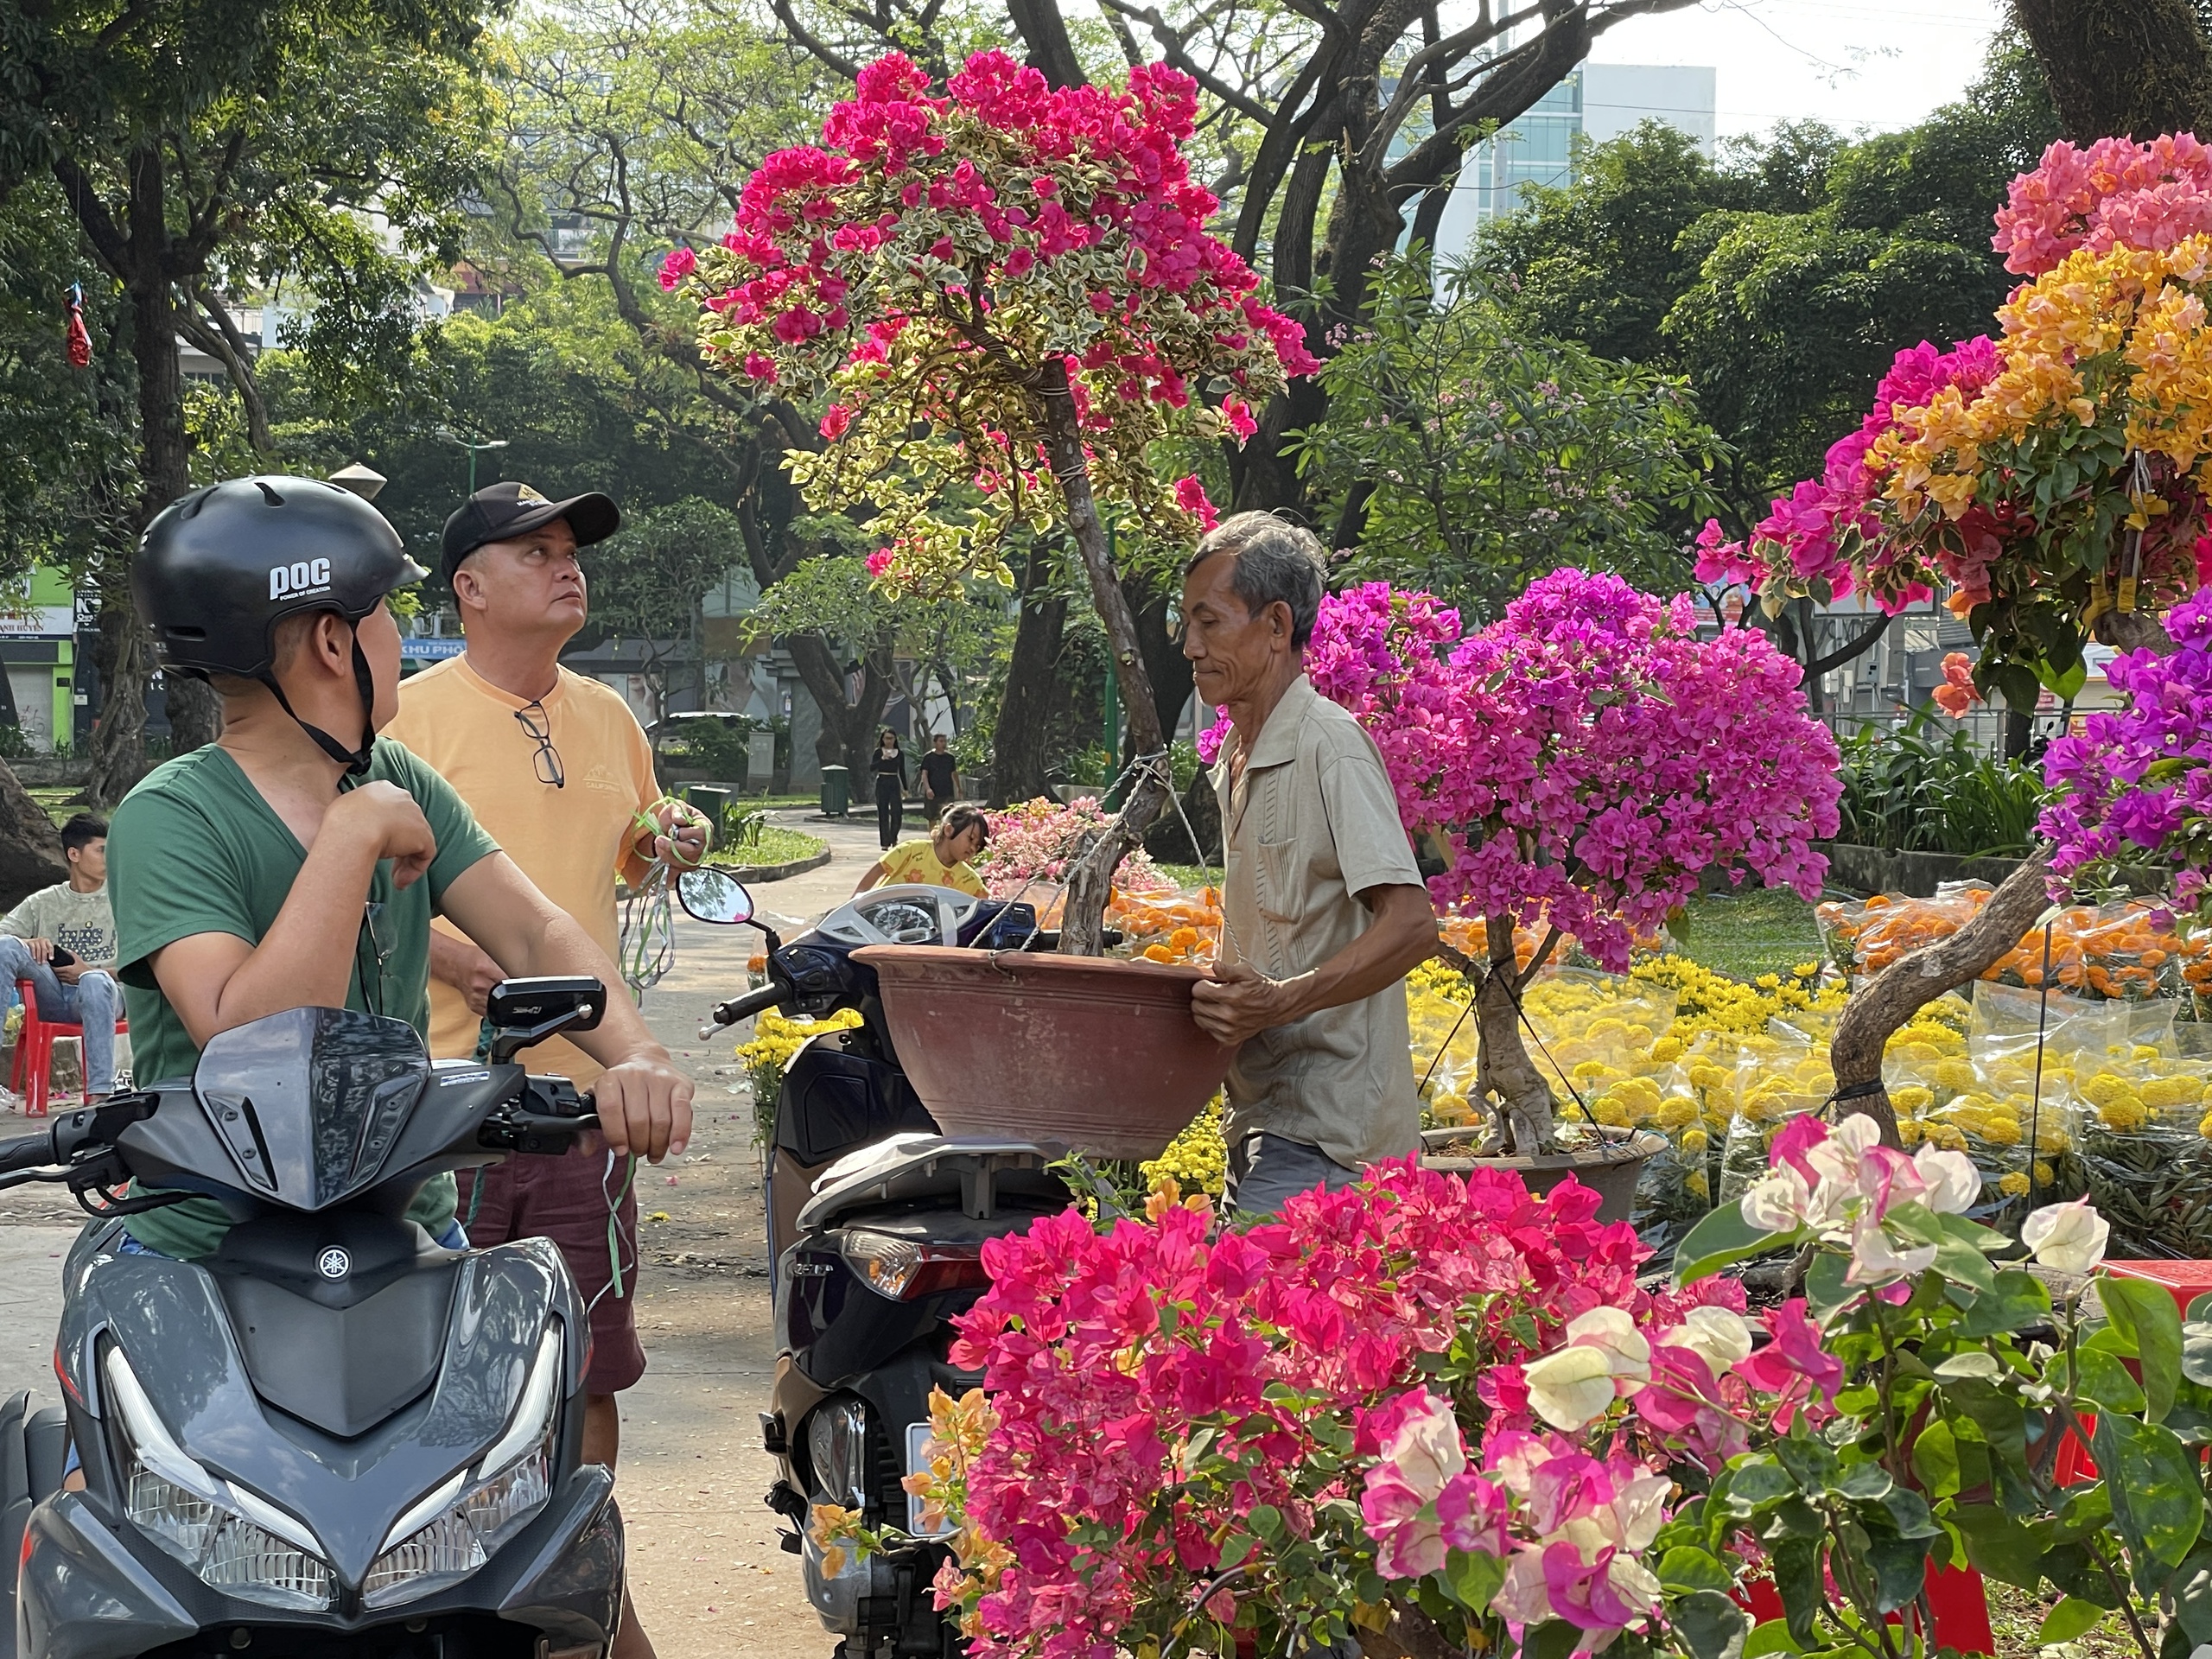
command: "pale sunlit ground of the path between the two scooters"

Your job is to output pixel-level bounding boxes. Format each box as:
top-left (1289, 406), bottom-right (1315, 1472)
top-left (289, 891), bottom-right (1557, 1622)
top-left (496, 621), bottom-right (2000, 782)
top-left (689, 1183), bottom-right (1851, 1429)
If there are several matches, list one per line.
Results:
top-left (0, 812), bottom-right (889, 1659)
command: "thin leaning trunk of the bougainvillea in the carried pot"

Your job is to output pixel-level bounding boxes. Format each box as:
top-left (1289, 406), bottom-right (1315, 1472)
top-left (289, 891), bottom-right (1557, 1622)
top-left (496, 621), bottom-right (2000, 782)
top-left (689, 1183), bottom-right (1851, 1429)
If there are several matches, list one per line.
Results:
top-left (1042, 359), bottom-right (1170, 956)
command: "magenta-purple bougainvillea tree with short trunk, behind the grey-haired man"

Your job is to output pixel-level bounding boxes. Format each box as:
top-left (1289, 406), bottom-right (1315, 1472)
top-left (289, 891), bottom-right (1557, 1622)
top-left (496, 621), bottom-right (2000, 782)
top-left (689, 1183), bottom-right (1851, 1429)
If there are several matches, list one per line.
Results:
top-left (1208, 570), bottom-right (1842, 1153)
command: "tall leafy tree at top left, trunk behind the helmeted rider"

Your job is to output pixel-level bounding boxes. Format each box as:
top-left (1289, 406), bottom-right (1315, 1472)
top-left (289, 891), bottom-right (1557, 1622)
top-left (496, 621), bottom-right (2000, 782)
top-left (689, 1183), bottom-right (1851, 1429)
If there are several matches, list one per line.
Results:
top-left (0, 0), bottom-right (499, 801)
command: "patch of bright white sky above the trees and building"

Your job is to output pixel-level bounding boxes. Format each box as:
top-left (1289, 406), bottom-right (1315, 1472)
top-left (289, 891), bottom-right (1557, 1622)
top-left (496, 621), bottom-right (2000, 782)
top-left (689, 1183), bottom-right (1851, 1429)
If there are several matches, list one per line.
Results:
top-left (1591, 0), bottom-right (2004, 137)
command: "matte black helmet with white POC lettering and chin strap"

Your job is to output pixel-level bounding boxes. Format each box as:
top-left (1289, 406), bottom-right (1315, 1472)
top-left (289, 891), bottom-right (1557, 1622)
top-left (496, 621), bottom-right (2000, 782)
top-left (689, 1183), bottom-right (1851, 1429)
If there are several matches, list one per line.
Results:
top-left (130, 478), bottom-right (429, 777)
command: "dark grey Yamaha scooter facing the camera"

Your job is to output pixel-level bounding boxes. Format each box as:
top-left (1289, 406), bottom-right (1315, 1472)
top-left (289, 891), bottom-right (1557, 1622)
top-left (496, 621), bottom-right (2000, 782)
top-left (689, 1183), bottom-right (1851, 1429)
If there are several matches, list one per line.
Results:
top-left (0, 980), bottom-right (624, 1659)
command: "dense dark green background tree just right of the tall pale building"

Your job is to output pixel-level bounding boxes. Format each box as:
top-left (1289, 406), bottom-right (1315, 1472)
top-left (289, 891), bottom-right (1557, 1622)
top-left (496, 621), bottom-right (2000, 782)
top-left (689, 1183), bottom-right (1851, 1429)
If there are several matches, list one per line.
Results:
top-left (1480, 38), bottom-right (2057, 529)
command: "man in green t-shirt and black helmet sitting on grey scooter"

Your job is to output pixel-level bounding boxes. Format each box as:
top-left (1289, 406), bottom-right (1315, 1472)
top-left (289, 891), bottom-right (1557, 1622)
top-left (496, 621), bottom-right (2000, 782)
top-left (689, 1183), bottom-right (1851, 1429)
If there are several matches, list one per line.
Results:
top-left (108, 478), bottom-right (692, 1259)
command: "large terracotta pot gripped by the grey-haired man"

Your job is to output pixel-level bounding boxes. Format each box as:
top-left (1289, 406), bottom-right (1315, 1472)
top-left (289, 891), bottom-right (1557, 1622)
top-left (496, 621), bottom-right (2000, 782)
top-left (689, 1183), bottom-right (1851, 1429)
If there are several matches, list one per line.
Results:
top-left (854, 944), bottom-right (1236, 1157)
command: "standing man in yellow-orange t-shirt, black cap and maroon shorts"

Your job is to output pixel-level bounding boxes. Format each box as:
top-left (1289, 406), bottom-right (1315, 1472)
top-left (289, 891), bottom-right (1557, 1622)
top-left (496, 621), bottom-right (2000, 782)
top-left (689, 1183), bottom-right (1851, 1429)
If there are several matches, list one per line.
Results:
top-left (385, 482), bottom-right (706, 1659)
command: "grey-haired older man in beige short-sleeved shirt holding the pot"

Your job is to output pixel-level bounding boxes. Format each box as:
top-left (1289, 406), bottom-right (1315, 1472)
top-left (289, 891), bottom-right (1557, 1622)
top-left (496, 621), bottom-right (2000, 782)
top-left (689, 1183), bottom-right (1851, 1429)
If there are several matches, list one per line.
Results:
top-left (1184, 513), bottom-right (1435, 1214)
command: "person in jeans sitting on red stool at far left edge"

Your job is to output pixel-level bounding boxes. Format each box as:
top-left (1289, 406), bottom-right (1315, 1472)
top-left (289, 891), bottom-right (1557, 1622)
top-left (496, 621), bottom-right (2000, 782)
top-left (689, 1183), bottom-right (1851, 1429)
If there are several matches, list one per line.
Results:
top-left (0, 812), bottom-right (122, 1103)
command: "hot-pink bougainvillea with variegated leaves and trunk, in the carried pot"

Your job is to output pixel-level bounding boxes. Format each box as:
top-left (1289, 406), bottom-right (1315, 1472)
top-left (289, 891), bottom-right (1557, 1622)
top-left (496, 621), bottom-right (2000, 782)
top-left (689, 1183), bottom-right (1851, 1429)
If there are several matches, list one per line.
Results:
top-left (668, 51), bottom-right (1314, 953)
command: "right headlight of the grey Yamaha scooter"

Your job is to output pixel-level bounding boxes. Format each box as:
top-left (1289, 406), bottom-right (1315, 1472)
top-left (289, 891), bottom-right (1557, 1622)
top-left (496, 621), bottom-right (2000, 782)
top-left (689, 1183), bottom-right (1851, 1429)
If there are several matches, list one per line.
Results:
top-left (360, 1325), bottom-right (562, 1608)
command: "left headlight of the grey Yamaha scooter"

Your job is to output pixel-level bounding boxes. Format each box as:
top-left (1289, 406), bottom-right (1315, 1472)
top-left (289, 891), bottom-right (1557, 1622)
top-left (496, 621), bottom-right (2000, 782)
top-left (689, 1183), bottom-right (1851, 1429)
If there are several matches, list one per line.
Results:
top-left (102, 1347), bottom-right (332, 1612)
